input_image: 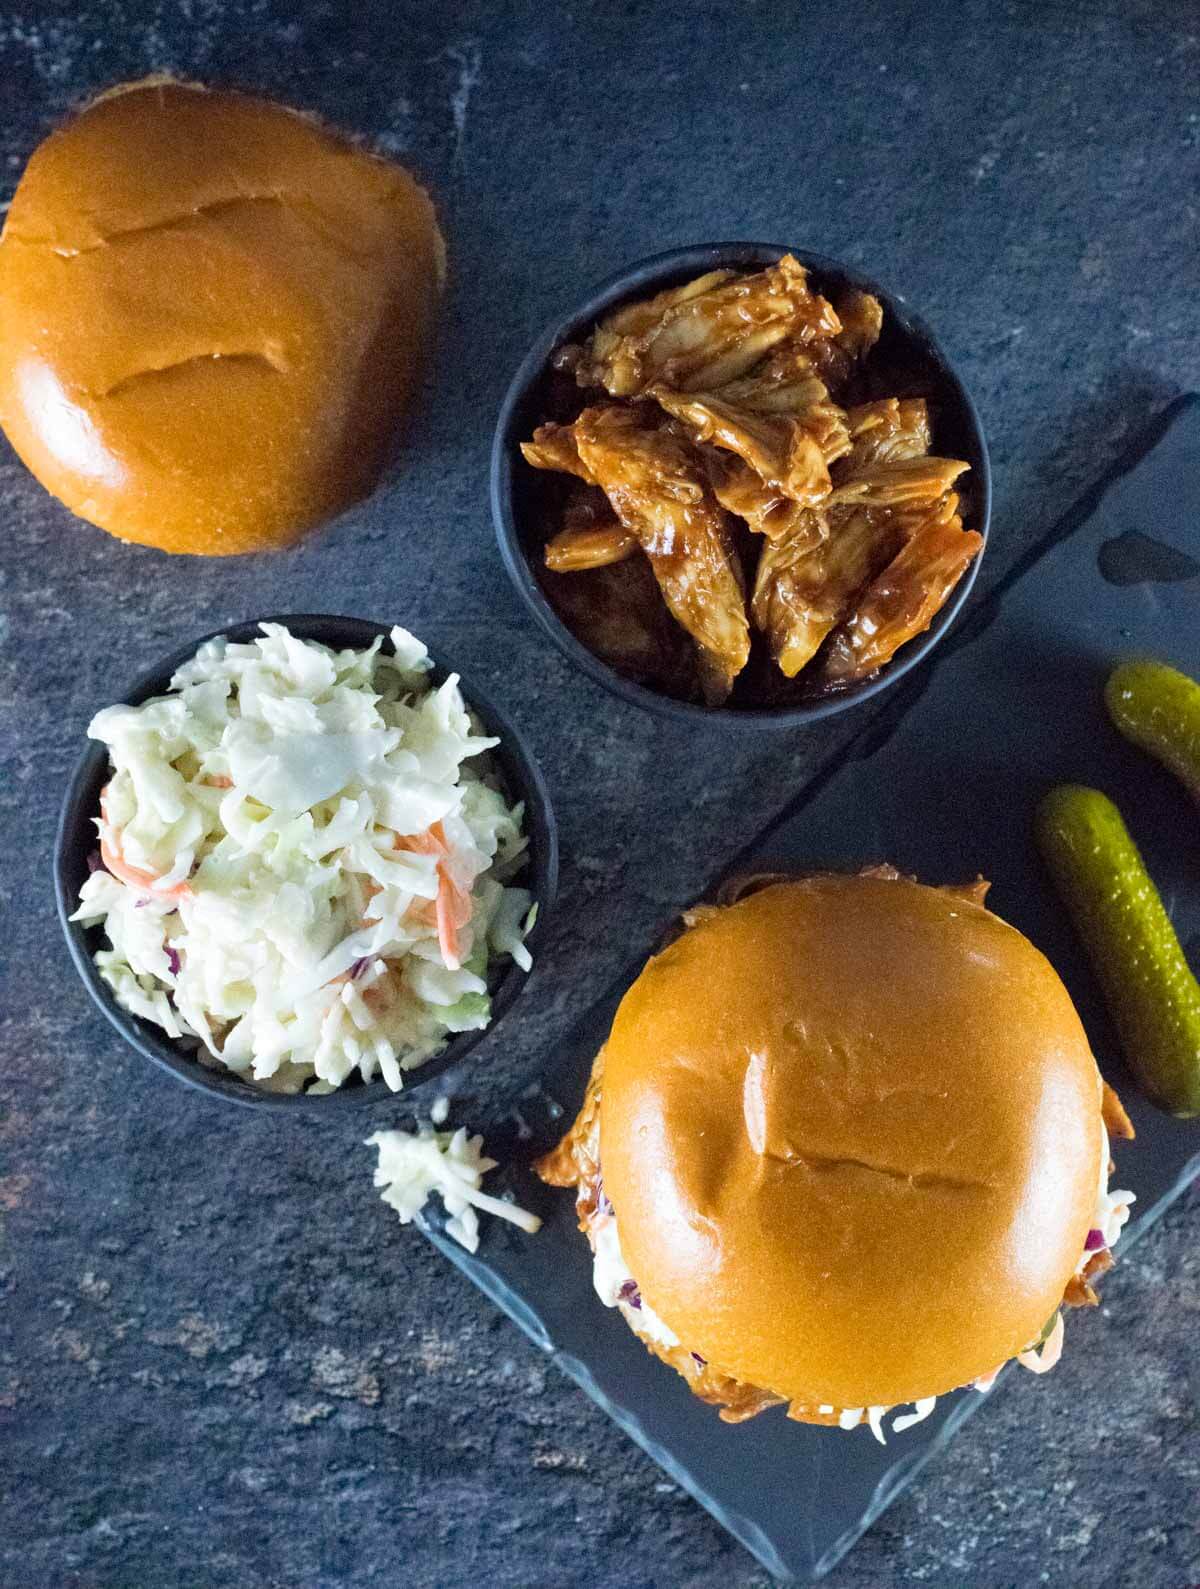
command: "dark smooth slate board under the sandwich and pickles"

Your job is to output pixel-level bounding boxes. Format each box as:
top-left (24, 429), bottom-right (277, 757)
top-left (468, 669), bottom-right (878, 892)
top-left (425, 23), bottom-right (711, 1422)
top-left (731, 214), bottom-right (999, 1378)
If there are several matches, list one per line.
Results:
top-left (426, 399), bottom-right (1200, 1581)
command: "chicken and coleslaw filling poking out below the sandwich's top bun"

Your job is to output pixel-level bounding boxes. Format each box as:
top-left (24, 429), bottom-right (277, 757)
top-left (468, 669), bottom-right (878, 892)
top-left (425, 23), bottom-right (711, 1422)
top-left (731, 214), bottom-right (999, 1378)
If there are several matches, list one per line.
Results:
top-left (536, 1054), bottom-right (1135, 1444)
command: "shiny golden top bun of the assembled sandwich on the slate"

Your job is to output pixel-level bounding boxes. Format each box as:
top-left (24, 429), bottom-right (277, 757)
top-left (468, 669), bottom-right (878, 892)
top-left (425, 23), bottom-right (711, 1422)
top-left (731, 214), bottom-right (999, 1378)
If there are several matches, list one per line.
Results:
top-left (599, 876), bottom-right (1105, 1409)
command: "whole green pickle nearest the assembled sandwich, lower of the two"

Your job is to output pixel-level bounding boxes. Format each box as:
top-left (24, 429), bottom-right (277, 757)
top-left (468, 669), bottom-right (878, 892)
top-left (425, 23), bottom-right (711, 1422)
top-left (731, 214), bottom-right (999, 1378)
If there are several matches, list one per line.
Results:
top-left (1038, 783), bottom-right (1200, 1117)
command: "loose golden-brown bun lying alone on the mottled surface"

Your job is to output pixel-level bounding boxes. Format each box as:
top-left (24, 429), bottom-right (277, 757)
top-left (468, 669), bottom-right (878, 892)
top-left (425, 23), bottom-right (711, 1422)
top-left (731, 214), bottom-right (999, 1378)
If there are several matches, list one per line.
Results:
top-left (0, 81), bottom-right (443, 555)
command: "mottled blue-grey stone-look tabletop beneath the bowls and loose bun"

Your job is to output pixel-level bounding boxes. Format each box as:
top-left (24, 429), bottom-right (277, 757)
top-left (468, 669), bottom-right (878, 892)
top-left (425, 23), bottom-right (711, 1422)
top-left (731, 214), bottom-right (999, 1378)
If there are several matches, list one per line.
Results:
top-left (0, 0), bottom-right (1200, 1589)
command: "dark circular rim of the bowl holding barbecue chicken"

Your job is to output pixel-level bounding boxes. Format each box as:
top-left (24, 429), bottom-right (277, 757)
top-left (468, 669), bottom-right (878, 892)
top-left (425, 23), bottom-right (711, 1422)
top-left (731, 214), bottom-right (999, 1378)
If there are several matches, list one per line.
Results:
top-left (490, 242), bottom-right (992, 733)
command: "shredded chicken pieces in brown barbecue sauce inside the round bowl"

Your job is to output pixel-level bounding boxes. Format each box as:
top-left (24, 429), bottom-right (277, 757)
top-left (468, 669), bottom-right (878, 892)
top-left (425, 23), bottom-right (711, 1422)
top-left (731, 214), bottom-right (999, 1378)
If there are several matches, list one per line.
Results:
top-left (521, 254), bottom-right (982, 706)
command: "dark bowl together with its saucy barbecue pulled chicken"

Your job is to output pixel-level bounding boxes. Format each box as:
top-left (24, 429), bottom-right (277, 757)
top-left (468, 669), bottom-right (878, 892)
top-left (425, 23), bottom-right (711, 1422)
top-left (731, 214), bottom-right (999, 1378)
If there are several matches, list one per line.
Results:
top-left (493, 243), bottom-right (990, 723)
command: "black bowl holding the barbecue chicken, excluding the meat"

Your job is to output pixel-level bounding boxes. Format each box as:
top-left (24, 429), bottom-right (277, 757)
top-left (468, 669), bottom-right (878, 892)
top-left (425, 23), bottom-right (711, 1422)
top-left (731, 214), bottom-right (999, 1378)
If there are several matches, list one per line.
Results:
top-left (491, 243), bottom-right (992, 729)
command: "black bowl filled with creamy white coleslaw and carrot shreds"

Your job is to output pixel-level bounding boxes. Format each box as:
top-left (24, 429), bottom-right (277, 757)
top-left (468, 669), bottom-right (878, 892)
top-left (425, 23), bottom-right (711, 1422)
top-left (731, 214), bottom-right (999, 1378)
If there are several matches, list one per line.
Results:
top-left (54, 615), bottom-right (558, 1109)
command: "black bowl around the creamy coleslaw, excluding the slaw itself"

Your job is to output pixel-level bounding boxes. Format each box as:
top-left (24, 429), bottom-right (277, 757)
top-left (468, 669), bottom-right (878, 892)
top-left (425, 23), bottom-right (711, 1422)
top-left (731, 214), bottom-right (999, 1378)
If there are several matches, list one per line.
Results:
top-left (54, 613), bottom-right (558, 1112)
